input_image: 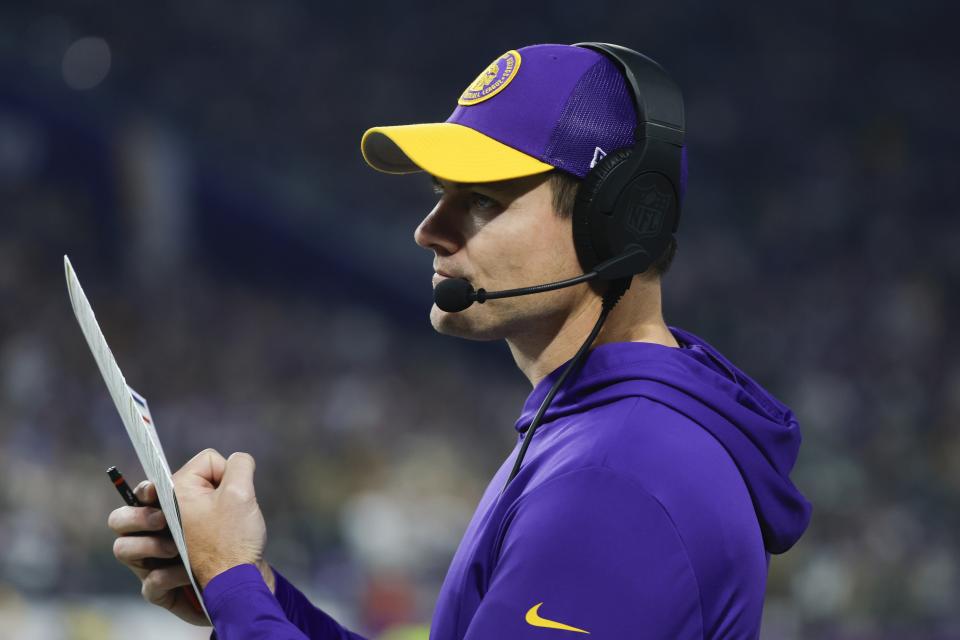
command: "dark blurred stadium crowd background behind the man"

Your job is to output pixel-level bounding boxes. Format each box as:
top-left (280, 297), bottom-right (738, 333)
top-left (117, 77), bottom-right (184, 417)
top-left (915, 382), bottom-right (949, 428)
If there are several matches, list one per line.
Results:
top-left (0, 0), bottom-right (960, 640)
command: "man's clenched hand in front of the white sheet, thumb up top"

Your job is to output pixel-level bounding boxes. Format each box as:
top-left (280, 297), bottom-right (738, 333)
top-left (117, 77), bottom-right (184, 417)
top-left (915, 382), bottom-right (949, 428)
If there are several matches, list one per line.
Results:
top-left (173, 449), bottom-right (272, 589)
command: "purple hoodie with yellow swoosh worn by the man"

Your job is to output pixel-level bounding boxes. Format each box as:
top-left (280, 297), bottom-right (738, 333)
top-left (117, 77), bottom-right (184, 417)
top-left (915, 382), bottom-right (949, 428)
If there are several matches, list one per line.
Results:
top-left (204, 327), bottom-right (811, 640)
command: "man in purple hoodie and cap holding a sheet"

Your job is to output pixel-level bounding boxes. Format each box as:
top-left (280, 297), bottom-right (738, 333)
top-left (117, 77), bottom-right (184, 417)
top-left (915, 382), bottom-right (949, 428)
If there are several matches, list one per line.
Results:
top-left (110, 45), bottom-right (810, 640)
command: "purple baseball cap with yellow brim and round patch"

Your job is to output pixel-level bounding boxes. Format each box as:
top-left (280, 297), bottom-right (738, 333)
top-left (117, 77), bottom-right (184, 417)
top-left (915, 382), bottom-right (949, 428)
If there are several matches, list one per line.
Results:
top-left (360, 44), bottom-right (648, 183)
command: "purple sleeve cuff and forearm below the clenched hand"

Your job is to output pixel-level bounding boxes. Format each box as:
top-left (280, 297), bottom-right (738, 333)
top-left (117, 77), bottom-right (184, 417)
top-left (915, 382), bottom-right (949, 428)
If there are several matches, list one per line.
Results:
top-left (203, 564), bottom-right (365, 640)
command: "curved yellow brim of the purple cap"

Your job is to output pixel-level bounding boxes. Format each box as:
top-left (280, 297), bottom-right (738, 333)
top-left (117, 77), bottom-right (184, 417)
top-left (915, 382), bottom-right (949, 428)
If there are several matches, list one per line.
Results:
top-left (360, 122), bottom-right (553, 183)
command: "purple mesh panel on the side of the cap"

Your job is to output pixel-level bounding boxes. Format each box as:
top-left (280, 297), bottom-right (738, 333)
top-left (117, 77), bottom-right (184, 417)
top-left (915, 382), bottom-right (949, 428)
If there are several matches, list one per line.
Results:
top-left (544, 54), bottom-right (637, 178)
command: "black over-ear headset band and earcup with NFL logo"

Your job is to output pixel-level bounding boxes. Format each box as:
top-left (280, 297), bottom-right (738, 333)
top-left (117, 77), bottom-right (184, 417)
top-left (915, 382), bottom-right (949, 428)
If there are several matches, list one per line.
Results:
top-left (573, 42), bottom-right (686, 289)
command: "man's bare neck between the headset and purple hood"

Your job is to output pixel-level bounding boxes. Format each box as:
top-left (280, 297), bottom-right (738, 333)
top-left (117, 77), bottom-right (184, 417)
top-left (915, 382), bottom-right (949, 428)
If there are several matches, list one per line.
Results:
top-left (507, 278), bottom-right (680, 386)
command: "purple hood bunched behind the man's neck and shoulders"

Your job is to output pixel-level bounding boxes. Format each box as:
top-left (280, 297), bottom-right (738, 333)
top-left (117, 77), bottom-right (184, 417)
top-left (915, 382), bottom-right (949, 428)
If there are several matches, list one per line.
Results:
top-left (515, 327), bottom-right (812, 553)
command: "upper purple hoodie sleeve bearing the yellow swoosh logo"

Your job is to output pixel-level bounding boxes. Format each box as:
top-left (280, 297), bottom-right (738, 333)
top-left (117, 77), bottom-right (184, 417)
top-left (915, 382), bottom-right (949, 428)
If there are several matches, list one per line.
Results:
top-left (464, 467), bottom-right (703, 640)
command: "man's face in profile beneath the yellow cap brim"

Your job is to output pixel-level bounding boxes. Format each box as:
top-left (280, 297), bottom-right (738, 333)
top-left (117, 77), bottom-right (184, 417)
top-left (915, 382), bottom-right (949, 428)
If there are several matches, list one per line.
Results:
top-left (414, 174), bottom-right (590, 340)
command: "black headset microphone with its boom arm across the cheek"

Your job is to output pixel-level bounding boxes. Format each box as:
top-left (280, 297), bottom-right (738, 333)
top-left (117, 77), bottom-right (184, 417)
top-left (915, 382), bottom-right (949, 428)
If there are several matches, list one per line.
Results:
top-left (433, 245), bottom-right (649, 313)
